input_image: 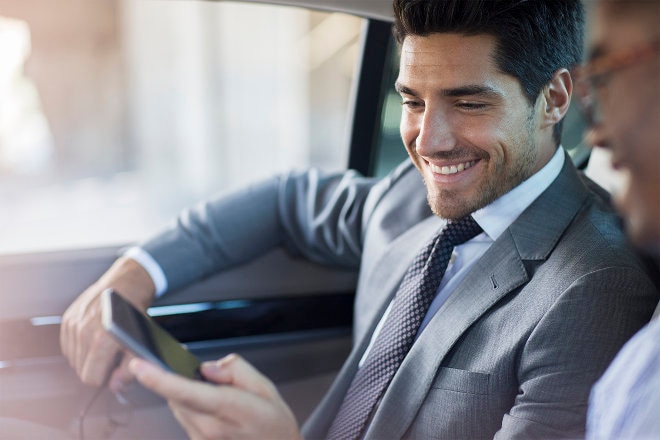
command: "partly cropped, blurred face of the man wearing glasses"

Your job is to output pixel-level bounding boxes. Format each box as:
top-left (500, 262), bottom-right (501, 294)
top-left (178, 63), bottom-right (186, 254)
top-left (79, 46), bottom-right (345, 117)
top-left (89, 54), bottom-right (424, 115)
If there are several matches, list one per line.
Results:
top-left (587, 1), bottom-right (660, 247)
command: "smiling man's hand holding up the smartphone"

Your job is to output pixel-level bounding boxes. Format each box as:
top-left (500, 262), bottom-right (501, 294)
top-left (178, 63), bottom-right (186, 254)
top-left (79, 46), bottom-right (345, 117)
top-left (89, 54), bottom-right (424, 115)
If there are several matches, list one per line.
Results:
top-left (130, 354), bottom-right (302, 440)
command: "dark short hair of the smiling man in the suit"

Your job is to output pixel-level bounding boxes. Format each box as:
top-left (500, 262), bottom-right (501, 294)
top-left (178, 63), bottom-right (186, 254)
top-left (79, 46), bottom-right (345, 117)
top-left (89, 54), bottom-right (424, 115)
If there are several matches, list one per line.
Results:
top-left (393, 0), bottom-right (584, 143)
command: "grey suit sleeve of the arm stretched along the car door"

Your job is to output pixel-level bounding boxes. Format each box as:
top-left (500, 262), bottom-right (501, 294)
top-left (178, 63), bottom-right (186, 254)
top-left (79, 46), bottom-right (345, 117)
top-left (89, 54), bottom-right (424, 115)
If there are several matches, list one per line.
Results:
top-left (141, 170), bottom-right (375, 291)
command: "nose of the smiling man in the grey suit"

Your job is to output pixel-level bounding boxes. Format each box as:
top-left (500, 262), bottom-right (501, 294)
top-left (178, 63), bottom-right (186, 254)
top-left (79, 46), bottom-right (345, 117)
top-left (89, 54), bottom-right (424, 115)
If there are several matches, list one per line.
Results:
top-left (415, 107), bottom-right (456, 157)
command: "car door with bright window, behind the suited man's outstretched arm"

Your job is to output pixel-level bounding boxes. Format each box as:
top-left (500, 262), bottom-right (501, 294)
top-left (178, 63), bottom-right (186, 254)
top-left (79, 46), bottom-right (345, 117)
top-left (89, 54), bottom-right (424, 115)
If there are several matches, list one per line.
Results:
top-left (0, 0), bottom-right (393, 438)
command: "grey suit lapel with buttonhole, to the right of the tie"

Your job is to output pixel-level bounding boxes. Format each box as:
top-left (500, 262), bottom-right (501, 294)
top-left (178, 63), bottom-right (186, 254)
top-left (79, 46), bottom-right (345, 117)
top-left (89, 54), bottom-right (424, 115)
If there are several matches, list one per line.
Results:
top-left (365, 154), bottom-right (588, 439)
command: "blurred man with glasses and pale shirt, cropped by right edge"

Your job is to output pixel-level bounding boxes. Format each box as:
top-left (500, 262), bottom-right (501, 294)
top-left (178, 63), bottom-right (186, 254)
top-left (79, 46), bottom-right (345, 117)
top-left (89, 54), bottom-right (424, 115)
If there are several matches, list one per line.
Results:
top-left (579, 0), bottom-right (660, 439)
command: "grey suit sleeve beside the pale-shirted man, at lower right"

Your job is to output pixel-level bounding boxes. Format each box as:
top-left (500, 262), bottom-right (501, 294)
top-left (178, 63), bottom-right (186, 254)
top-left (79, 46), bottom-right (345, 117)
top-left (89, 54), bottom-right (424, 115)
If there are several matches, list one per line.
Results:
top-left (495, 267), bottom-right (658, 439)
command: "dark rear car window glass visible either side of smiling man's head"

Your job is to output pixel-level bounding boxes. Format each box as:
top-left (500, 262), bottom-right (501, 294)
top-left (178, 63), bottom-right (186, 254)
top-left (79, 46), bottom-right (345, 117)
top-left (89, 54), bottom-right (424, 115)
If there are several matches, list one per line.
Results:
top-left (371, 42), bottom-right (590, 177)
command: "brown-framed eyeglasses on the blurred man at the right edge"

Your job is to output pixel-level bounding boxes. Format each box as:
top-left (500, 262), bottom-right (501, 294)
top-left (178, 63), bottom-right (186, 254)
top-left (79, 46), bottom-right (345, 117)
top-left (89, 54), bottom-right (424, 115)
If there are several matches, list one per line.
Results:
top-left (571, 40), bottom-right (660, 126)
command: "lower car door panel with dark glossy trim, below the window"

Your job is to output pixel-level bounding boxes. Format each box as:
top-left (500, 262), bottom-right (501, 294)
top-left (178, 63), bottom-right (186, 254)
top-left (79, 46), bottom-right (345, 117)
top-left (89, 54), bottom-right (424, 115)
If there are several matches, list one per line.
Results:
top-left (0, 248), bottom-right (356, 434)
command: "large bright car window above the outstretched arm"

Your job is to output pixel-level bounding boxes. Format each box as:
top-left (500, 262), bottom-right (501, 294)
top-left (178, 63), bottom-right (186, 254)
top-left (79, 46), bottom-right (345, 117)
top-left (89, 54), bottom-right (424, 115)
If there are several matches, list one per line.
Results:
top-left (0, 0), bottom-right (362, 254)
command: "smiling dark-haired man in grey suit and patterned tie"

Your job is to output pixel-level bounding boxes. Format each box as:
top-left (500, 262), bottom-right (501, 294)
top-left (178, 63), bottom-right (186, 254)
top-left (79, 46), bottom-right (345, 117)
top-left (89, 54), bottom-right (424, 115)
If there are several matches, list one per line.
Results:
top-left (61, 0), bottom-right (657, 439)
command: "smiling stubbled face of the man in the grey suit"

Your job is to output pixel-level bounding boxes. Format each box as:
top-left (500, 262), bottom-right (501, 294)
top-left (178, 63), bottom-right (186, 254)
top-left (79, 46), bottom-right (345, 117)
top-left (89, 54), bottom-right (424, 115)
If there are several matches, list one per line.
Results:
top-left (396, 34), bottom-right (555, 219)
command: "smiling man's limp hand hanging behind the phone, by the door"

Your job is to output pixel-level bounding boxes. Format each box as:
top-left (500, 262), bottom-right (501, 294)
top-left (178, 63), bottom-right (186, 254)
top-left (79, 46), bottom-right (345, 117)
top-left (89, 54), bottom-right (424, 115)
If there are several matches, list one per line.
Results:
top-left (60, 257), bottom-right (155, 391)
